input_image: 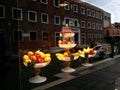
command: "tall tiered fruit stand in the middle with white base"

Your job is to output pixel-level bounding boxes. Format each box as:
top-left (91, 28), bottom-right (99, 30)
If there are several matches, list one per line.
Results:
top-left (56, 24), bottom-right (79, 72)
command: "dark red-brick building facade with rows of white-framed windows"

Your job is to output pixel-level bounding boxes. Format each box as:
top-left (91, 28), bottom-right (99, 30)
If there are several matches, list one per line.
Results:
top-left (0, 0), bottom-right (110, 54)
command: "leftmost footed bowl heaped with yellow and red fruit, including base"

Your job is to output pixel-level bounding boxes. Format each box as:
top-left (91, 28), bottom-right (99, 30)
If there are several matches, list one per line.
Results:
top-left (23, 50), bottom-right (51, 83)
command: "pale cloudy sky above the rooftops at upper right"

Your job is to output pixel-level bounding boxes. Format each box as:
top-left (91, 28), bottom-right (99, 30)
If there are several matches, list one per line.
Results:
top-left (82, 0), bottom-right (120, 23)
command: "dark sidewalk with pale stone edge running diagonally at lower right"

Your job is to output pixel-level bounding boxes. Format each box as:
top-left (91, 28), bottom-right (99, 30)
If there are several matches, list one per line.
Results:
top-left (32, 55), bottom-right (120, 90)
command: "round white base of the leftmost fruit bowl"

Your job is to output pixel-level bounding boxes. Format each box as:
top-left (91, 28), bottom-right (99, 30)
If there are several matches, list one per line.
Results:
top-left (29, 76), bottom-right (47, 83)
